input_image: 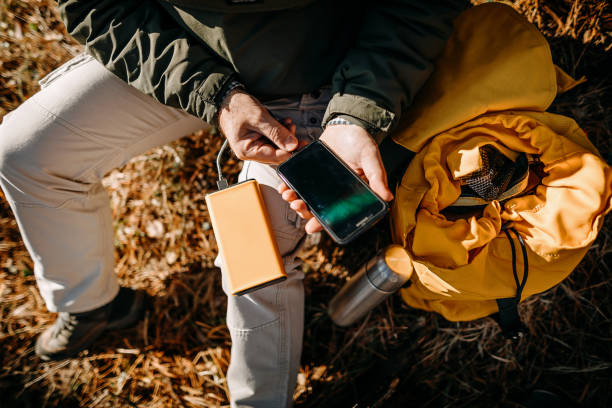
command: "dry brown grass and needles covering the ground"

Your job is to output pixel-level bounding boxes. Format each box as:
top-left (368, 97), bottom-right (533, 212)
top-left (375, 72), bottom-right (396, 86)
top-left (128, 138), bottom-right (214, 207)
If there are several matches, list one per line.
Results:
top-left (0, 0), bottom-right (612, 407)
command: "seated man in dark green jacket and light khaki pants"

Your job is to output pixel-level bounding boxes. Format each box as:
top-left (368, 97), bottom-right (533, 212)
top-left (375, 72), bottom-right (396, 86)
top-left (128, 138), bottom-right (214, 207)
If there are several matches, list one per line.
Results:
top-left (0, 0), bottom-right (465, 407)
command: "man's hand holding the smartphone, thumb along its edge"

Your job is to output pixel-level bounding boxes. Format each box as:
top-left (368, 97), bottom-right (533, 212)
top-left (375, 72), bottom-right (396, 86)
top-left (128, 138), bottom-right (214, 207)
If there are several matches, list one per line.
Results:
top-left (278, 125), bottom-right (393, 234)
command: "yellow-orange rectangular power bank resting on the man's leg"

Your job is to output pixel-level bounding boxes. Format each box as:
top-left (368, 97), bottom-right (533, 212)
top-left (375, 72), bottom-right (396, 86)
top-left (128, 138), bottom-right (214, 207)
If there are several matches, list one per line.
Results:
top-left (206, 180), bottom-right (287, 295)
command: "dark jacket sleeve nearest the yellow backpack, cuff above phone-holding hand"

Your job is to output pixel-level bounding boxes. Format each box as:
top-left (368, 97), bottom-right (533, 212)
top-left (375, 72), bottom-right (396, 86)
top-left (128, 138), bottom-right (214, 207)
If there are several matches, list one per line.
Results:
top-left (323, 0), bottom-right (468, 142)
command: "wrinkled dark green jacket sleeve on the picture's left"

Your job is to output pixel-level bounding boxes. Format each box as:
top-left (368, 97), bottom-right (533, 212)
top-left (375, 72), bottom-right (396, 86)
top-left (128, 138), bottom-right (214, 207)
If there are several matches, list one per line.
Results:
top-left (58, 0), bottom-right (235, 123)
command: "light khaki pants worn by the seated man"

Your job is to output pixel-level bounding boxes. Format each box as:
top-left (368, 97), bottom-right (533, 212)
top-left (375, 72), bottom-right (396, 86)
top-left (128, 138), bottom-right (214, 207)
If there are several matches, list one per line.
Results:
top-left (0, 55), bottom-right (329, 408)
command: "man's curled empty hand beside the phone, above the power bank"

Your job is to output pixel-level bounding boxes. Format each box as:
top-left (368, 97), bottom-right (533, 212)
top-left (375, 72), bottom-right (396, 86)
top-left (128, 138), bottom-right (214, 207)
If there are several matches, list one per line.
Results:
top-left (219, 89), bottom-right (298, 164)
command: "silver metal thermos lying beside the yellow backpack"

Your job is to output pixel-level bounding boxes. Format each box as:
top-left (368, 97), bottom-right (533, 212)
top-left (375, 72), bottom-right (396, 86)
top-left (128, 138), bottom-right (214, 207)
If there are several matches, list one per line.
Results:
top-left (327, 245), bottom-right (413, 326)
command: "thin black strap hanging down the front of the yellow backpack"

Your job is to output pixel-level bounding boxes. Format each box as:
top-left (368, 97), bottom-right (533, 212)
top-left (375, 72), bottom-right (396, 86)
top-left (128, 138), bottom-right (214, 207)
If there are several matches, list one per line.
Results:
top-left (493, 228), bottom-right (529, 341)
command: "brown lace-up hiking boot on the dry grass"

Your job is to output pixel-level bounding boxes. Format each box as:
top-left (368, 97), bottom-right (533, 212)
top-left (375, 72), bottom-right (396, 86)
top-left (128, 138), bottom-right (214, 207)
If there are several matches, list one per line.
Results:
top-left (35, 288), bottom-right (144, 361)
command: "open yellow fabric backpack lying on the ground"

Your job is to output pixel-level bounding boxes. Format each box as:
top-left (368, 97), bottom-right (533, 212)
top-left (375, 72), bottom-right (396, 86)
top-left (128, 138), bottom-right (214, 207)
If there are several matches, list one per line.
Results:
top-left (391, 3), bottom-right (612, 337)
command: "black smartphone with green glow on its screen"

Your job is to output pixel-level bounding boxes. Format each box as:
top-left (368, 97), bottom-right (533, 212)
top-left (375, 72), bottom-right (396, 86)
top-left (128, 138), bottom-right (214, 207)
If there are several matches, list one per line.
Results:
top-left (277, 141), bottom-right (389, 244)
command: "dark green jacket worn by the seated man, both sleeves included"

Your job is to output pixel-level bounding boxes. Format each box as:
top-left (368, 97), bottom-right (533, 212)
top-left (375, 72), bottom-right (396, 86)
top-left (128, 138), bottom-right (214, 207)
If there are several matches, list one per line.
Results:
top-left (58, 0), bottom-right (466, 139)
